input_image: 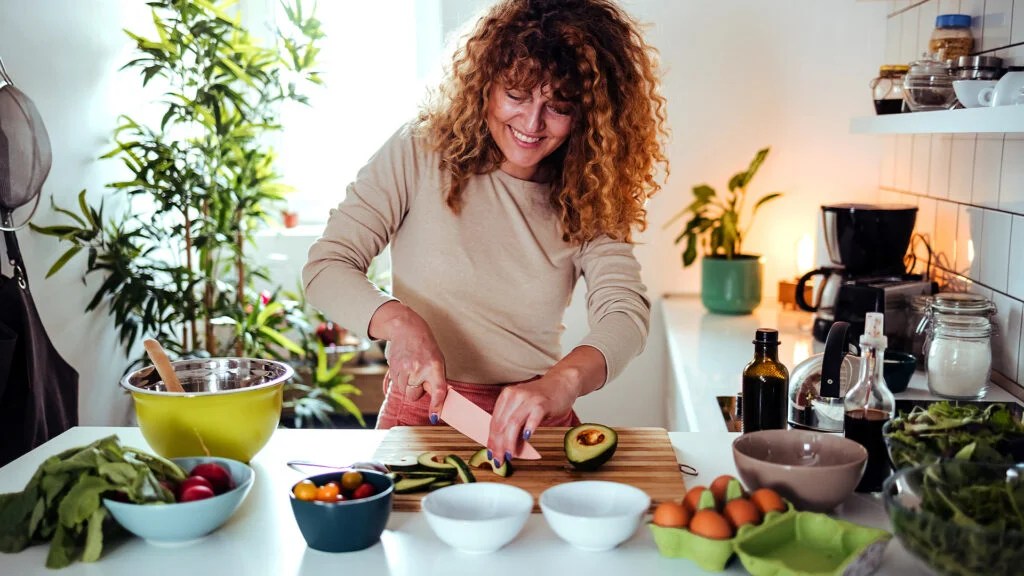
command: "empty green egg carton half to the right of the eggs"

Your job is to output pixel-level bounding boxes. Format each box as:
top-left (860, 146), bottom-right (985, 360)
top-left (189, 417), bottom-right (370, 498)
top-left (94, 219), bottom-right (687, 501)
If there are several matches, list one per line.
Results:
top-left (732, 512), bottom-right (892, 576)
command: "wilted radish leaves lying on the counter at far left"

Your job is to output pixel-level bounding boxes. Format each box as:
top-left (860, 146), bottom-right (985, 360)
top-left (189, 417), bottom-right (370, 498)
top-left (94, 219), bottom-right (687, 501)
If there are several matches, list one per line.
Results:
top-left (0, 436), bottom-right (185, 568)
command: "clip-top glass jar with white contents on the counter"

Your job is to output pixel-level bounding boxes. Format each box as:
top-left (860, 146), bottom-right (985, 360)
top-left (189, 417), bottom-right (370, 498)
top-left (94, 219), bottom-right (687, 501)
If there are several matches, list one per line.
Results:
top-left (919, 292), bottom-right (996, 400)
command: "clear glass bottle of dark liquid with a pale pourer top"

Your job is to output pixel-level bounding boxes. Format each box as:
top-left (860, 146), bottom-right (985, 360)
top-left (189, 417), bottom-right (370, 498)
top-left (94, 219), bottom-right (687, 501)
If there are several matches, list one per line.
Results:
top-left (843, 312), bottom-right (896, 492)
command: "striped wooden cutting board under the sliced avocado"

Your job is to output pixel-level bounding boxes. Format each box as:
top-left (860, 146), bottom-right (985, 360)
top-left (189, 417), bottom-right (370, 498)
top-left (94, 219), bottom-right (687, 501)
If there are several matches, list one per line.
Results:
top-left (374, 425), bottom-right (686, 512)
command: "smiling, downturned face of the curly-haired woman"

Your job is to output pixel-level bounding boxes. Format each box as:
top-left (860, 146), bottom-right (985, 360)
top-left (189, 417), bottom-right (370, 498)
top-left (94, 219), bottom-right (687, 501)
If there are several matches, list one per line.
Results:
top-left (487, 82), bottom-right (572, 180)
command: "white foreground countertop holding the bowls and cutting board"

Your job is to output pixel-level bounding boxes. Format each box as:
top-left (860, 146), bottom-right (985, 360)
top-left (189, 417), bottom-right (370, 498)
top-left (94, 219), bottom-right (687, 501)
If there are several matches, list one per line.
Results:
top-left (0, 426), bottom-right (929, 576)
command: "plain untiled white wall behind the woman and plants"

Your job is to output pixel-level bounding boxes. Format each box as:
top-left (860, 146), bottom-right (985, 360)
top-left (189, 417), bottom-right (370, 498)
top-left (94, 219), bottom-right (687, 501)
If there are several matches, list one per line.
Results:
top-left (0, 0), bottom-right (886, 425)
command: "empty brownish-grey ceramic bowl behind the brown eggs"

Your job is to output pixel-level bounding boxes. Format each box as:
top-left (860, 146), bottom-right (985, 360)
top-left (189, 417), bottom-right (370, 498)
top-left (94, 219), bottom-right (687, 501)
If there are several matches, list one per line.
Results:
top-left (732, 429), bottom-right (867, 512)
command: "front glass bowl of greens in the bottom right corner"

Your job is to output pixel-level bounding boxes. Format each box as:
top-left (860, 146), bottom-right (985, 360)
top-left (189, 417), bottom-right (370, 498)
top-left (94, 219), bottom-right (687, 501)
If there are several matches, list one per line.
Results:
top-left (883, 460), bottom-right (1024, 576)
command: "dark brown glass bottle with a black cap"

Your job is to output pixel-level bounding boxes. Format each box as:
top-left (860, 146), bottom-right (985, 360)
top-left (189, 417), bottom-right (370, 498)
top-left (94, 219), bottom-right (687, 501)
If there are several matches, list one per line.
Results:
top-left (743, 328), bottom-right (790, 433)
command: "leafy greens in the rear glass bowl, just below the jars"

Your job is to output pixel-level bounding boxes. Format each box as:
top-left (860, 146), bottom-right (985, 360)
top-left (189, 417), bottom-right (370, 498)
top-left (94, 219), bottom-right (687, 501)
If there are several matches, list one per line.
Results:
top-left (886, 401), bottom-right (1024, 469)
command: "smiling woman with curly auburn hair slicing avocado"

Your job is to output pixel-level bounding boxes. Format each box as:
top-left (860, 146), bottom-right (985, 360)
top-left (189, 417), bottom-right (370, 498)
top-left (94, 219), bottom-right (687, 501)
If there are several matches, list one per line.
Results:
top-left (303, 0), bottom-right (668, 465)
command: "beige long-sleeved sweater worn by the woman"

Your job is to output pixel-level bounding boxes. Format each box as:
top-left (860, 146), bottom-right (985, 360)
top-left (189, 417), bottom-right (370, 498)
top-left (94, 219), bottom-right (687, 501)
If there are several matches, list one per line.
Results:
top-left (302, 127), bottom-right (650, 383)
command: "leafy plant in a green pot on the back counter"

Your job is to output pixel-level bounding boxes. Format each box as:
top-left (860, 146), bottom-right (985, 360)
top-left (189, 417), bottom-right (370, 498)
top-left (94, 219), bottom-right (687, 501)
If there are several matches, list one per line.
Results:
top-left (665, 148), bottom-right (782, 314)
